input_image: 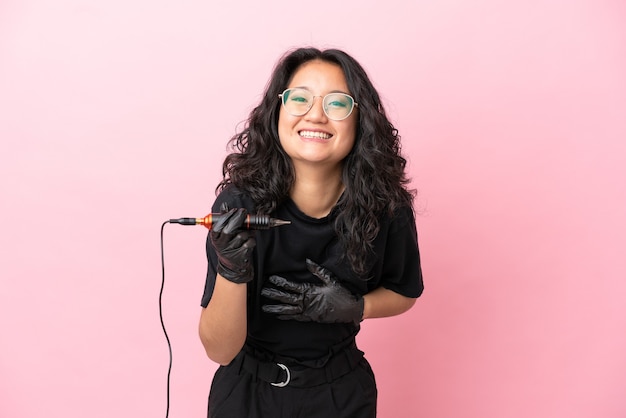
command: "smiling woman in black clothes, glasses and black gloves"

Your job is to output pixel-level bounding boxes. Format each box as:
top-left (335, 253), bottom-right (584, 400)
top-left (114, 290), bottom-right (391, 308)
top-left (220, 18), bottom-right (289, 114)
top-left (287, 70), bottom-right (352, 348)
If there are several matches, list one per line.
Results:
top-left (199, 48), bottom-right (423, 418)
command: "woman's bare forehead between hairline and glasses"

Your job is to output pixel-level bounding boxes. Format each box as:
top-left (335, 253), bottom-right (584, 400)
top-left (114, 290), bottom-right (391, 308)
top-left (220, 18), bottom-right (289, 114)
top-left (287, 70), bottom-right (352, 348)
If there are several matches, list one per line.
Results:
top-left (289, 60), bottom-right (348, 91)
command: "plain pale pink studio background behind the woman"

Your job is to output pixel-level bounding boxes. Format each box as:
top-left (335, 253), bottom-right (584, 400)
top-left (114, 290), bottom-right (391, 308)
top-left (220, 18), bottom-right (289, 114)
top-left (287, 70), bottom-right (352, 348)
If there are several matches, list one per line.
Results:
top-left (0, 0), bottom-right (626, 418)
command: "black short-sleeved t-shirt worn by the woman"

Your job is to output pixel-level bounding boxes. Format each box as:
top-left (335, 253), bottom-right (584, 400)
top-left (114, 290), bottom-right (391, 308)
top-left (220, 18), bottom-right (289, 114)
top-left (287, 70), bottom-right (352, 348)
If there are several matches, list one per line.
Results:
top-left (201, 186), bottom-right (423, 361)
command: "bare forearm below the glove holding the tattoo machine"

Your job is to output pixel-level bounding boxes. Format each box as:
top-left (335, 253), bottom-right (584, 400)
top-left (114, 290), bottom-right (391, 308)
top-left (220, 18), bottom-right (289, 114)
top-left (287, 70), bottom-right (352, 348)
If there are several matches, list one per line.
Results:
top-left (199, 274), bottom-right (247, 366)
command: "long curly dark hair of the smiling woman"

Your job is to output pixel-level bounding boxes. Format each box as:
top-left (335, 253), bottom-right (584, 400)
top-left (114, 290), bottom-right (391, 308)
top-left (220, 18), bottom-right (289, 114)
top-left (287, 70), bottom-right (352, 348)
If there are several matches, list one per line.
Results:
top-left (217, 48), bottom-right (415, 275)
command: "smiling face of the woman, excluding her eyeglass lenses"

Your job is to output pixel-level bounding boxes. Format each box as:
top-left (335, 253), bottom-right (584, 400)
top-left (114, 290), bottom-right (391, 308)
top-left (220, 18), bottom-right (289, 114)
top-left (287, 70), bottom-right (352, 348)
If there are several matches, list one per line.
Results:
top-left (278, 60), bottom-right (358, 168)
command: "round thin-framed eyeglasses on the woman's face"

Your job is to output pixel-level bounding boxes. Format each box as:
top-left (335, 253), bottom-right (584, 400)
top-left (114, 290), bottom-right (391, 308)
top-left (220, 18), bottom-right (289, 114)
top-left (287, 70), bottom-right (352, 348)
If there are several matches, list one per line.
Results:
top-left (278, 88), bottom-right (359, 120)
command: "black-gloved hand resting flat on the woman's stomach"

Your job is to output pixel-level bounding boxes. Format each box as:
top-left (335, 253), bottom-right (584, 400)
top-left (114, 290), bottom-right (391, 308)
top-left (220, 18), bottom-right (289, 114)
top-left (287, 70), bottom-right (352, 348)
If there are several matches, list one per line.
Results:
top-left (261, 259), bottom-right (364, 324)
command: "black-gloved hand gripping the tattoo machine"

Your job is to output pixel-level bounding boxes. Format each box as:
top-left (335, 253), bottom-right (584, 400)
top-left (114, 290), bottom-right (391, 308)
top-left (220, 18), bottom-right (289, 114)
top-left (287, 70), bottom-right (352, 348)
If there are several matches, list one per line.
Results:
top-left (209, 204), bottom-right (256, 283)
